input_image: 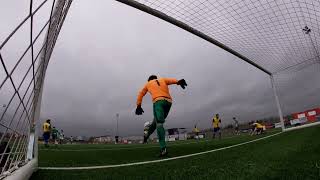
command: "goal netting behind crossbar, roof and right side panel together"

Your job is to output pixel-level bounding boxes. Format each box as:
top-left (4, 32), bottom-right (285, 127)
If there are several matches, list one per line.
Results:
top-left (118, 0), bottom-right (320, 127)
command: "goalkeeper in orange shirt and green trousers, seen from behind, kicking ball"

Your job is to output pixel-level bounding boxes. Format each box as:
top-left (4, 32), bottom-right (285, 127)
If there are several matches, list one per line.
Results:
top-left (136, 75), bottom-right (187, 157)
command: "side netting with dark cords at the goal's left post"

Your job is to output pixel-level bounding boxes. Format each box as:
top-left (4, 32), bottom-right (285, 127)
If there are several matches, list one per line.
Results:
top-left (0, 0), bottom-right (72, 178)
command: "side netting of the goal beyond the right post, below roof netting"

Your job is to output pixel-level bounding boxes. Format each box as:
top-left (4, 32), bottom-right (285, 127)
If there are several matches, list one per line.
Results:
top-left (274, 62), bottom-right (320, 122)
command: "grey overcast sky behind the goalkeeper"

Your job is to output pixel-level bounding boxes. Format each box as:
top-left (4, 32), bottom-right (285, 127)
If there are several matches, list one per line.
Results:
top-left (0, 0), bottom-right (319, 136)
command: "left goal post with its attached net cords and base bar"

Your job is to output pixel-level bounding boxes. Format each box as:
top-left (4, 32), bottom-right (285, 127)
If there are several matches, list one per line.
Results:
top-left (0, 0), bottom-right (72, 180)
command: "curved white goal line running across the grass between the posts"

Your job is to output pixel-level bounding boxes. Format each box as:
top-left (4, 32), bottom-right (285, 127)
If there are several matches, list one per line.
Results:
top-left (39, 132), bottom-right (282, 170)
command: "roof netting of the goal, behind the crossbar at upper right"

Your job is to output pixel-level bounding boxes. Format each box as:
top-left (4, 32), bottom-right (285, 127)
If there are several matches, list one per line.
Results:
top-left (123, 0), bottom-right (320, 73)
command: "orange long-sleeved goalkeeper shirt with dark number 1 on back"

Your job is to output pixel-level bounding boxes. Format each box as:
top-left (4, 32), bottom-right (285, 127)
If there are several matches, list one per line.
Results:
top-left (137, 78), bottom-right (178, 105)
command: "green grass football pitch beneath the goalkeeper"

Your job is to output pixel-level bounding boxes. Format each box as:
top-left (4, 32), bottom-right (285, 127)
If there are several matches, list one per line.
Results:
top-left (31, 126), bottom-right (320, 180)
